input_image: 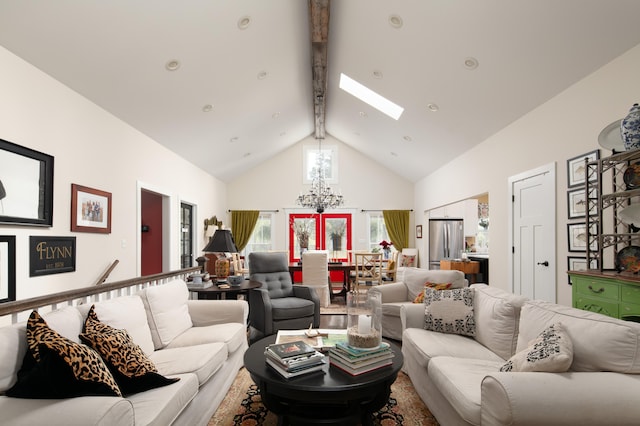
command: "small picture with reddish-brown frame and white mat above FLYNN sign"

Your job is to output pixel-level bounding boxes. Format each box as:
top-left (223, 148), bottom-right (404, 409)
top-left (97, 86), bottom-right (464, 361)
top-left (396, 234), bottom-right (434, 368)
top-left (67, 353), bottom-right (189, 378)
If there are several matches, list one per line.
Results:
top-left (71, 183), bottom-right (111, 234)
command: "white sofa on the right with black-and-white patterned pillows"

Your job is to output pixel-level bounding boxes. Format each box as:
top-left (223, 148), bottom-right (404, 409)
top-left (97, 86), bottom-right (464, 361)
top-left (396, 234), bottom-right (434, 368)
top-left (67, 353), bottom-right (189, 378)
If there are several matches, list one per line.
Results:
top-left (401, 284), bottom-right (640, 426)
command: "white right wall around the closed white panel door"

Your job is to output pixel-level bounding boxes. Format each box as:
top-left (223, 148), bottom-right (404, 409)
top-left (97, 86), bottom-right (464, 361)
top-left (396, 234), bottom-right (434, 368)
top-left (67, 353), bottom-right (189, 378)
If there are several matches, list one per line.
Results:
top-left (414, 45), bottom-right (640, 305)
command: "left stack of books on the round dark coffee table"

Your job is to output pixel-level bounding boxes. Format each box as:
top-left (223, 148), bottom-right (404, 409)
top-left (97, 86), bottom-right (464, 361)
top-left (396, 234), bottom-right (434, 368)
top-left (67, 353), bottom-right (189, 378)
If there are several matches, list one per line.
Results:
top-left (264, 340), bottom-right (326, 379)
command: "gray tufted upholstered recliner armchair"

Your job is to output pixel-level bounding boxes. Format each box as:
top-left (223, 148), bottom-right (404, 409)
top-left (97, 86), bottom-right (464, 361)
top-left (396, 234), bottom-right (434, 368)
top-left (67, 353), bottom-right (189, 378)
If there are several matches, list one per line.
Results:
top-left (249, 253), bottom-right (320, 336)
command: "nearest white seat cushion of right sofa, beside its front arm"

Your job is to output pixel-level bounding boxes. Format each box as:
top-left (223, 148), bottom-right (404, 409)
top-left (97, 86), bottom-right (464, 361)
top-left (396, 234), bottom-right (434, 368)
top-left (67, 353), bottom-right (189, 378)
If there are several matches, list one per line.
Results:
top-left (428, 356), bottom-right (502, 425)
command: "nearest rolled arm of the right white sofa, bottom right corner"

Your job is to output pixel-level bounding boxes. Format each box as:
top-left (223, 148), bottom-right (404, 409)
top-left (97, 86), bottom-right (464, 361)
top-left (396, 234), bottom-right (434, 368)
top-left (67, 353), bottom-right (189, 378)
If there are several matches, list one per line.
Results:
top-left (481, 372), bottom-right (640, 426)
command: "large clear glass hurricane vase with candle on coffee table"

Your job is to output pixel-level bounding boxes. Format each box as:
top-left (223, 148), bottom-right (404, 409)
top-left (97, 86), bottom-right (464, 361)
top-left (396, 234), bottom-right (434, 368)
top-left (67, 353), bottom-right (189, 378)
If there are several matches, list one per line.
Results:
top-left (347, 291), bottom-right (382, 349)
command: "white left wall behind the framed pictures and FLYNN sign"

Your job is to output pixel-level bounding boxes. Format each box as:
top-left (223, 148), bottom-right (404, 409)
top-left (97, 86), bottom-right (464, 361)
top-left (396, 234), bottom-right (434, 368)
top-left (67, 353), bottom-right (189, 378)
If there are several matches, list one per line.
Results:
top-left (0, 47), bottom-right (226, 299)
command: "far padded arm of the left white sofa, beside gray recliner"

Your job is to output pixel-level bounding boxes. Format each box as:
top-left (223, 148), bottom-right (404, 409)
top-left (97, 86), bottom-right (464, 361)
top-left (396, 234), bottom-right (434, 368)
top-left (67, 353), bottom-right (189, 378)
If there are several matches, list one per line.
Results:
top-left (187, 300), bottom-right (249, 327)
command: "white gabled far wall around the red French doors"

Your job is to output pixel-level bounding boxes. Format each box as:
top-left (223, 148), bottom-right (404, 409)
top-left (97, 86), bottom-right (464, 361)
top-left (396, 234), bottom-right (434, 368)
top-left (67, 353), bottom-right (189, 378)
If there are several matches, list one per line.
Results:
top-left (227, 135), bottom-right (415, 250)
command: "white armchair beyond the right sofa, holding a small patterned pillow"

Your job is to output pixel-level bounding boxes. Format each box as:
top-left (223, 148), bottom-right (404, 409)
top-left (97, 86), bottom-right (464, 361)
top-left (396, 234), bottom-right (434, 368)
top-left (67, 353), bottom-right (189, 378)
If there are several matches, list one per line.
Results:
top-left (369, 267), bottom-right (469, 340)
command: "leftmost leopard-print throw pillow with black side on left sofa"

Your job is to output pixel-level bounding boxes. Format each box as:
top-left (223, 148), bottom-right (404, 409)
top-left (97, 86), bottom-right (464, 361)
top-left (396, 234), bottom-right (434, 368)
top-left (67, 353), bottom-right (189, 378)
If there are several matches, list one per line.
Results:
top-left (6, 311), bottom-right (122, 398)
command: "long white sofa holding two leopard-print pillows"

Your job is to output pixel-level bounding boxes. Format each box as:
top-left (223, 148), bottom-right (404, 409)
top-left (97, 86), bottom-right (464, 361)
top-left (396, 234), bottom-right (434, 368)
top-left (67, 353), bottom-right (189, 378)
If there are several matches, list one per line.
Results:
top-left (0, 280), bottom-right (248, 426)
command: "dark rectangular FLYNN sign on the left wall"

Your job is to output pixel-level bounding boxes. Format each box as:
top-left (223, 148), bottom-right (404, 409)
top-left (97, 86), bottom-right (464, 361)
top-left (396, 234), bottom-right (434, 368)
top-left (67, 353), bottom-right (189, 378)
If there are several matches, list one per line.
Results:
top-left (29, 236), bottom-right (76, 277)
